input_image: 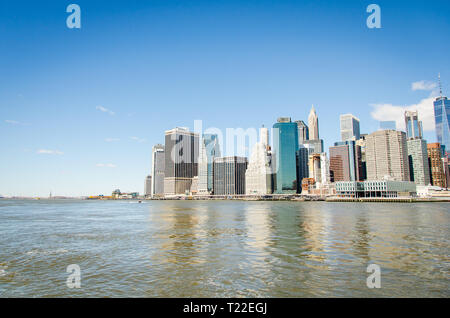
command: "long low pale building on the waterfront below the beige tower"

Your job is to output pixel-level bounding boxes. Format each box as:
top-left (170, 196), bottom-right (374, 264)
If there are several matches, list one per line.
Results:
top-left (335, 180), bottom-right (416, 198)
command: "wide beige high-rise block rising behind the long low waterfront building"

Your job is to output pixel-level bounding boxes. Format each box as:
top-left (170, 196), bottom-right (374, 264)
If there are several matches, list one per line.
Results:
top-left (366, 130), bottom-right (409, 181)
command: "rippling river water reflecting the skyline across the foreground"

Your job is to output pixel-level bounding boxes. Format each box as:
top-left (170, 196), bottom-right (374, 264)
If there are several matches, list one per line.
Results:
top-left (0, 200), bottom-right (450, 297)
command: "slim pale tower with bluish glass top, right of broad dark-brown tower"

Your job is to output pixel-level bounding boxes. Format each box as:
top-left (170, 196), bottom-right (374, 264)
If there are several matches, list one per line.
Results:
top-left (198, 134), bottom-right (220, 194)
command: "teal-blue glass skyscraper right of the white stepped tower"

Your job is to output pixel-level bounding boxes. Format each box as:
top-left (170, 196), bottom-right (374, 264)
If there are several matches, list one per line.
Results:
top-left (273, 118), bottom-right (299, 193)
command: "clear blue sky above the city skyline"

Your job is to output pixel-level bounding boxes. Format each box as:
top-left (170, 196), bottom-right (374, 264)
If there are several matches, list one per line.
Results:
top-left (0, 0), bottom-right (450, 196)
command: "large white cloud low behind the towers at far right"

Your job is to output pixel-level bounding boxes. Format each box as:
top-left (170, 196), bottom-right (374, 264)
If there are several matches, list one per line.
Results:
top-left (370, 97), bottom-right (435, 131)
